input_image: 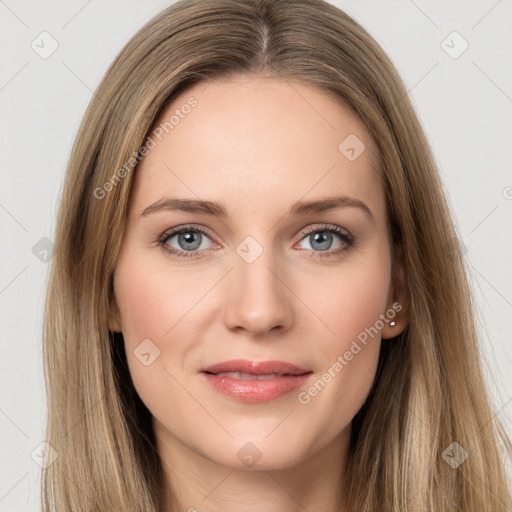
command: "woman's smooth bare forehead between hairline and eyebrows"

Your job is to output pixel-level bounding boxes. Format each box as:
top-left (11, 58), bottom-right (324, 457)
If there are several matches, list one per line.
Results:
top-left (130, 77), bottom-right (383, 222)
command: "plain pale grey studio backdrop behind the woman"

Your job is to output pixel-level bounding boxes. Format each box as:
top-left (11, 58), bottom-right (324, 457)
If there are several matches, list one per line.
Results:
top-left (0, 0), bottom-right (512, 512)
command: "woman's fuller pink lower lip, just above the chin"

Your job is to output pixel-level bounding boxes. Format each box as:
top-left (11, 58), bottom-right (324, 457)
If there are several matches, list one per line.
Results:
top-left (202, 372), bottom-right (311, 403)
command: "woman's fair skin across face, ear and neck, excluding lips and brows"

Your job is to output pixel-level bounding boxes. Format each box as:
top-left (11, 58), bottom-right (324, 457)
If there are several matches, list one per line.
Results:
top-left (110, 76), bottom-right (407, 512)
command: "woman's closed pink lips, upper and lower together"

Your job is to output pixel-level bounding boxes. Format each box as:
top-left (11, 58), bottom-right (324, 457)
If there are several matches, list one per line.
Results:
top-left (201, 359), bottom-right (313, 403)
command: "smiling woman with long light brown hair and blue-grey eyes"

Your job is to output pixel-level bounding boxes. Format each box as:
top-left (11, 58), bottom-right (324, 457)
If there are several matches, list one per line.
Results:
top-left (43, 0), bottom-right (511, 512)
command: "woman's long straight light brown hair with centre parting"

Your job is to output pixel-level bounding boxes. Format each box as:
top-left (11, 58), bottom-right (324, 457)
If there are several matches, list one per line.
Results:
top-left (41, 0), bottom-right (512, 512)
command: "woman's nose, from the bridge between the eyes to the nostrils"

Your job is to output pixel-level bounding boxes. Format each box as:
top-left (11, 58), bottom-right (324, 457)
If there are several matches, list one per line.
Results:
top-left (224, 246), bottom-right (294, 336)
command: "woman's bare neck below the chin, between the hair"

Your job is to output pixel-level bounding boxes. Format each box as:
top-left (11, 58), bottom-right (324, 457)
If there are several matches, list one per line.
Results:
top-left (154, 421), bottom-right (350, 512)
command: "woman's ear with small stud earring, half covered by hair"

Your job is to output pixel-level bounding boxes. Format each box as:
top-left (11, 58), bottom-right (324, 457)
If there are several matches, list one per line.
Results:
top-left (381, 245), bottom-right (409, 339)
